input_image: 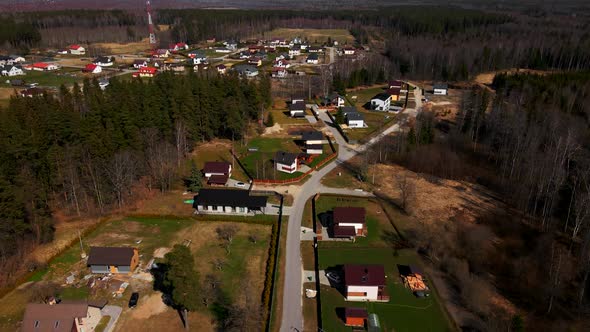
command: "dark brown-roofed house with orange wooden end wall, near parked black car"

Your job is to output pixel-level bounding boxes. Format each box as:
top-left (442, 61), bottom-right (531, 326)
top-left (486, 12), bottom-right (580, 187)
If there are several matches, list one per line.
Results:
top-left (86, 247), bottom-right (139, 273)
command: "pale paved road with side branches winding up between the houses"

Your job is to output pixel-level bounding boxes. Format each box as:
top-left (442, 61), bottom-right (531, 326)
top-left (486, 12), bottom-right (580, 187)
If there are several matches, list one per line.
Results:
top-left (281, 112), bottom-right (399, 332)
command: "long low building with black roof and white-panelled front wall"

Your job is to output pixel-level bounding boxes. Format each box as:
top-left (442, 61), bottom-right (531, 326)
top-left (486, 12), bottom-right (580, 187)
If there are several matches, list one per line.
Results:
top-left (193, 189), bottom-right (268, 214)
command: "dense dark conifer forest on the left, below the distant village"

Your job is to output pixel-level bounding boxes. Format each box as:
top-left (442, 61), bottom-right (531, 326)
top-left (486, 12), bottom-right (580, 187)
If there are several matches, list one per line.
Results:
top-left (0, 73), bottom-right (269, 285)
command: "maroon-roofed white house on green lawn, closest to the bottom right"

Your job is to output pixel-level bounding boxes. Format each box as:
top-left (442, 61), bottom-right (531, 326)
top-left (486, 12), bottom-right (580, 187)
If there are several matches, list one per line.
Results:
top-left (344, 264), bottom-right (389, 302)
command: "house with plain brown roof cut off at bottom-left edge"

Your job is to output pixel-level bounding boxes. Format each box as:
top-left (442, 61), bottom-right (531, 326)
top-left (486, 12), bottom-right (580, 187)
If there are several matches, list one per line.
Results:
top-left (20, 302), bottom-right (91, 332)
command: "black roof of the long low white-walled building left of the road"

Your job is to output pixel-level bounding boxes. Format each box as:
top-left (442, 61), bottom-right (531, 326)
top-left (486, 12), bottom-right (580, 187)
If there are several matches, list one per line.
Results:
top-left (193, 189), bottom-right (268, 208)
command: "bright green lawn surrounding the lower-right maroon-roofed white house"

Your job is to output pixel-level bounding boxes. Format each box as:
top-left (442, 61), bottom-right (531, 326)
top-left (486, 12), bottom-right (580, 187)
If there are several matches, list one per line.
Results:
top-left (319, 247), bottom-right (452, 332)
